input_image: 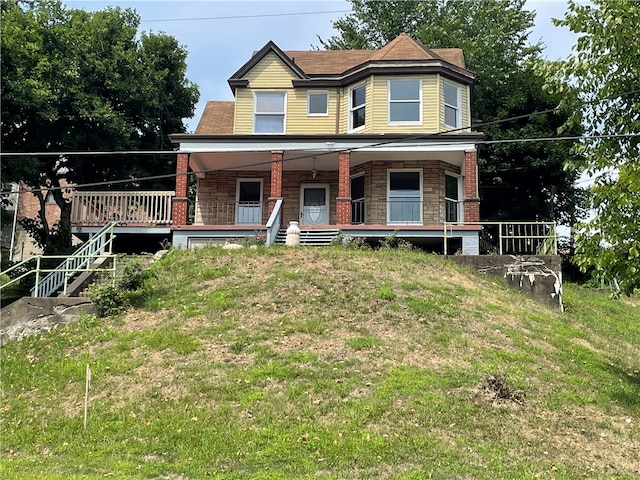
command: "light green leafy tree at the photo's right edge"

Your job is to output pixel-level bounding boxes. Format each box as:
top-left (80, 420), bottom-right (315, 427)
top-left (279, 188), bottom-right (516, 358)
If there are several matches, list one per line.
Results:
top-left (545, 0), bottom-right (640, 295)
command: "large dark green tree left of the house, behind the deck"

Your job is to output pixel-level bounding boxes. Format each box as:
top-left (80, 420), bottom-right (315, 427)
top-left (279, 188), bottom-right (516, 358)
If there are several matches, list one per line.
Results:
top-left (0, 0), bottom-right (199, 253)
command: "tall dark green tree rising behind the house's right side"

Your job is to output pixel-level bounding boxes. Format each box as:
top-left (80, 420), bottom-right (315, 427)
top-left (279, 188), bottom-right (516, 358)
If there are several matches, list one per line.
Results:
top-left (320, 0), bottom-right (581, 222)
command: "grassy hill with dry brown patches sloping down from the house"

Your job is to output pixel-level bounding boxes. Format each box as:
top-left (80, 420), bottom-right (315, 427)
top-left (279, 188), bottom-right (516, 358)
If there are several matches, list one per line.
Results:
top-left (0, 248), bottom-right (640, 480)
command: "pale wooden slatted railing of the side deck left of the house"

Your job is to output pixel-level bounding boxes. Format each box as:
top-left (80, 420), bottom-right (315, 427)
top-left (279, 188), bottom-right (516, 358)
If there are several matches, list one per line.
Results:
top-left (71, 191), bottom-right (174, 225)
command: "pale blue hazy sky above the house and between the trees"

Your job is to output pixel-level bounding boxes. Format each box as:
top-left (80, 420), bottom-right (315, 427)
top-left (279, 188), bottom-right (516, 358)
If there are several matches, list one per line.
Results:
top-left (65, 0), bottom-right (575, 131)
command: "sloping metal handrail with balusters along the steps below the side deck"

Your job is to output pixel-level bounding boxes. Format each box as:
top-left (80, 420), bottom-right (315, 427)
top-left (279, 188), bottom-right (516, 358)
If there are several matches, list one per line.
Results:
top-left (31, 222), bottom-right (116, 297)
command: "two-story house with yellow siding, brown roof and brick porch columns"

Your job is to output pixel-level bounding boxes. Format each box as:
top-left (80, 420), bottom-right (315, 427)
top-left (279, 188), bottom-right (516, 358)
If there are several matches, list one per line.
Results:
top-left (171, 34), bottom-right (481, 254)
